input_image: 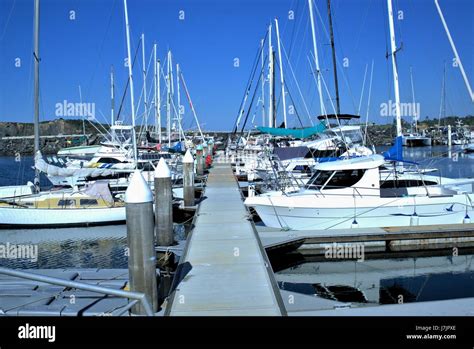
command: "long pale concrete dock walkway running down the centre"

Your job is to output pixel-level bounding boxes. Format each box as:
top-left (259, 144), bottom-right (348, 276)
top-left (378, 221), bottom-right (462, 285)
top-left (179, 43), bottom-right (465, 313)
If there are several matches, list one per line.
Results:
top-left (166, 164), bottom-right (286, 316)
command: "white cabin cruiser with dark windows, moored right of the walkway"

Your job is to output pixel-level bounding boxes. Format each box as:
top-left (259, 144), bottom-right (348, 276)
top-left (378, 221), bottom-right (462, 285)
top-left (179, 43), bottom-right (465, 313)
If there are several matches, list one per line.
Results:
top-left (245, 155), bottom-right (474, 230)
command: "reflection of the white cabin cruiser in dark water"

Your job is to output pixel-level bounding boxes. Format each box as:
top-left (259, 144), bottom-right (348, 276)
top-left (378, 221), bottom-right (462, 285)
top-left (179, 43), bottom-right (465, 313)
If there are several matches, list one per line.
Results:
top-left (275, 250), bottom-right (474, 305)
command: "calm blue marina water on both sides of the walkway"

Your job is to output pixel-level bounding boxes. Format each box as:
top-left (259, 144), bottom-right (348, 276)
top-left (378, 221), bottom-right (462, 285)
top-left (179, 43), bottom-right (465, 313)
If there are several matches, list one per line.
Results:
top-left (0, 146), bottom-right (474, 304)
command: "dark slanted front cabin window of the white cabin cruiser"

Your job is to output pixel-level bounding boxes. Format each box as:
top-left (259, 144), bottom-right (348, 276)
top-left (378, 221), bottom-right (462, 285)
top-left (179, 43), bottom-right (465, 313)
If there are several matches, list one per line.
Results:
top-left (306, 169), bottom-right (365, 190)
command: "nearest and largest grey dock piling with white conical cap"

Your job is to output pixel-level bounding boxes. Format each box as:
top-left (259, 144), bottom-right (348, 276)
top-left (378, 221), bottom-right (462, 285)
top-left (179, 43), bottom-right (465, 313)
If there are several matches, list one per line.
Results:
top-left (125, 170), bottom-right (158, 315)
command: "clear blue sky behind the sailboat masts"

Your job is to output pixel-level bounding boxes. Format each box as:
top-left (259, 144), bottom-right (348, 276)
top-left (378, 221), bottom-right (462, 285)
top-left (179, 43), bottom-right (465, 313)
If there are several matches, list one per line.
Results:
top-left (0, 0), bottom-right (474, 130)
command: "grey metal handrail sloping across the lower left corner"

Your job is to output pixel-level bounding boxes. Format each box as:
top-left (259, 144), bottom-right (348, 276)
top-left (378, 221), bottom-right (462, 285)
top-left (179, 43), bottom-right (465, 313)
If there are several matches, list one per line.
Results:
top-left (0, 267), bottom-right (154, 316)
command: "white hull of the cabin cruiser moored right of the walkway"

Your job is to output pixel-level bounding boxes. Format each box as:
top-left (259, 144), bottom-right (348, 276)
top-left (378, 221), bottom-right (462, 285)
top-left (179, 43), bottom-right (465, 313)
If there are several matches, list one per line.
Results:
top-left (246, 194), bottom-right (474, 230)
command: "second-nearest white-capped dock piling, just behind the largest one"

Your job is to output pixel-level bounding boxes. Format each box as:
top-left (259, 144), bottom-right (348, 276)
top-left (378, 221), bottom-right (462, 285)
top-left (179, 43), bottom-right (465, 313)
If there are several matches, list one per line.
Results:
top-left (155, 158), bottom-right (174, 246)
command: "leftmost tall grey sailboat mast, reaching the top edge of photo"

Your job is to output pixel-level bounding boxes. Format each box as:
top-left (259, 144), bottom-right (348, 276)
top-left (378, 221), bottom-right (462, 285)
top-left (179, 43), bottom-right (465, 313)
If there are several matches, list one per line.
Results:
top-left (33, 0), bottom-right (40, 191)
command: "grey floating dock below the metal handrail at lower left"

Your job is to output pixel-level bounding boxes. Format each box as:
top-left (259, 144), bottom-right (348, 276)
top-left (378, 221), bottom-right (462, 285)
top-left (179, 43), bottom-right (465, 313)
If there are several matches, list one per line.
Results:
top-left (0, 269), bottom-right (130, 316)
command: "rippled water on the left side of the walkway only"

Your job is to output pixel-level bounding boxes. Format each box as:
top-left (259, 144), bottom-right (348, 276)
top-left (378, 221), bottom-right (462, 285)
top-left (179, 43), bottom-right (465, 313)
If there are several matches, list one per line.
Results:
top-left (0, 157), bottom-right (185, 269)
